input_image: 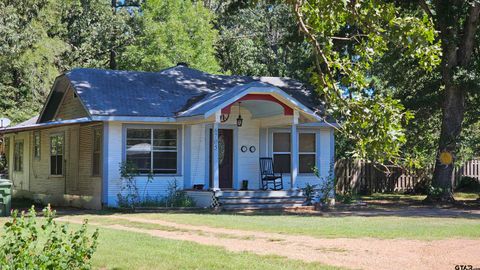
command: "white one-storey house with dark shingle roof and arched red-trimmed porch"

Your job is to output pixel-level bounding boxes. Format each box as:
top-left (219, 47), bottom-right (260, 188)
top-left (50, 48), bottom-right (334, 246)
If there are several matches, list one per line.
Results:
top-left (2, 64), bottom-right (334, 208)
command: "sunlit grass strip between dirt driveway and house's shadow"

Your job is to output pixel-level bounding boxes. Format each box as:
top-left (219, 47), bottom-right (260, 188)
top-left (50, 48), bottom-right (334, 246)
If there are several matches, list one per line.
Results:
top-left (119, 213), bottom-right (480, 240)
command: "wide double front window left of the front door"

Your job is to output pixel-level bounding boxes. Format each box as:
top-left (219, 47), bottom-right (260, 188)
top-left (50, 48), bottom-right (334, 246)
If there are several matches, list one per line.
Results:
top-left (127, 129), bottom-right (177, 174)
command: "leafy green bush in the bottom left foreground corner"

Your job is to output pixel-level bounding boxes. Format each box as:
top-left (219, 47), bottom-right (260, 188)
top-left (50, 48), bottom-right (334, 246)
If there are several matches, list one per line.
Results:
top-left (0, 206), bottom-right (98, 270)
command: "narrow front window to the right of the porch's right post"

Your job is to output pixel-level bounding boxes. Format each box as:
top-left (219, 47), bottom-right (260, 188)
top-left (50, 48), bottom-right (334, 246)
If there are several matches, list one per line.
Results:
top-left (298, 133), bottom-right (316, 173)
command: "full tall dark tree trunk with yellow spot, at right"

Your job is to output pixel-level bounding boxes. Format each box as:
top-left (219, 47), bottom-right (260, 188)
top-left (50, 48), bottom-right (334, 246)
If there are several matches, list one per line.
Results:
top-left (427, 1), bottom-right (480, 202)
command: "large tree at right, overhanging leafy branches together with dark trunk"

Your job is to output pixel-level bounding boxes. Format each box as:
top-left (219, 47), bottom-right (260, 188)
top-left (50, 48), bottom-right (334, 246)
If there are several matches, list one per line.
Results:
top-left (292, 0), bottom-right (480, 200)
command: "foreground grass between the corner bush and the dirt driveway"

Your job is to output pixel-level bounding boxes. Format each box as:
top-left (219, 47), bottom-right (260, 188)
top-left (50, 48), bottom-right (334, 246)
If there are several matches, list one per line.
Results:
top-left (82, 224), bottom-right (336, 269)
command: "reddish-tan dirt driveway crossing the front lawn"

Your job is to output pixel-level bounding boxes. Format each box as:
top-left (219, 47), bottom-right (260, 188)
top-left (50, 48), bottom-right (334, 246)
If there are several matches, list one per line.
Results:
top-left (59, 215), bottom-right (480, 269)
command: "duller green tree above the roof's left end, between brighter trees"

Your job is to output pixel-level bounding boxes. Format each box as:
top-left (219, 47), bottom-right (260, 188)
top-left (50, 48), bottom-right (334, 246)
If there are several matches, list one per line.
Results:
top-left (58, 0), bottom-right (139, 70)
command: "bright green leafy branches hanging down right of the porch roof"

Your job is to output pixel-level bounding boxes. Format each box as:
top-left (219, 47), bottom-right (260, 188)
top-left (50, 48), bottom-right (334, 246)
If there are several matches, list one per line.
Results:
top-left (293, 0), bottom-right (439, 165)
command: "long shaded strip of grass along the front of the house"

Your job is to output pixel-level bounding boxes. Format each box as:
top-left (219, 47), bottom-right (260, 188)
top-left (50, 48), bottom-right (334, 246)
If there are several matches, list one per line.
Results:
top-left (12, 194), bottom-right (480, 219)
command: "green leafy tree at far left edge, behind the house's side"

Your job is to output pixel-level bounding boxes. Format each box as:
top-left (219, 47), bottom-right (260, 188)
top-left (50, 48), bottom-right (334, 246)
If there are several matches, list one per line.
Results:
top-left (0, 0), bottom-right (68, 122)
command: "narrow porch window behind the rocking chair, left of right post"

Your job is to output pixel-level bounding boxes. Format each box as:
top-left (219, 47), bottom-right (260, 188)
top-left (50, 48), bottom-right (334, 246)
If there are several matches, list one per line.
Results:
top-left (272, 133), bottom-right (291, 173)
